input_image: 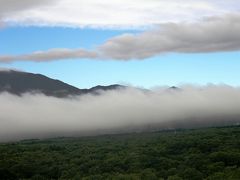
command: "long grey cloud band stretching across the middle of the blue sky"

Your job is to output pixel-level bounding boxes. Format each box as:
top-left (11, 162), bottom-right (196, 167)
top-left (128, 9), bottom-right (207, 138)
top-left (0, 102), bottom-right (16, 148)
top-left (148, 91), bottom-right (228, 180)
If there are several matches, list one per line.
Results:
top-left (0, 14), bottom-right (240, 62)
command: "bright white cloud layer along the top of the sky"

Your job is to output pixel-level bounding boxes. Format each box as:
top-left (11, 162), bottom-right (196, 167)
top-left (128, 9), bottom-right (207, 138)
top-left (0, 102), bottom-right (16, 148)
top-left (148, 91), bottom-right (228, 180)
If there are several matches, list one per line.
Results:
top-left (0, 0), bottom-right (240, 28)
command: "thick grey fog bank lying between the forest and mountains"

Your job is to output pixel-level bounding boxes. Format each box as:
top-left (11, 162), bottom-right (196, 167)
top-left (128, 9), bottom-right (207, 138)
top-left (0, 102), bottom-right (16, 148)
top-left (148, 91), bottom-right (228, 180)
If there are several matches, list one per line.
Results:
top-left (0, 85), bottom-right (240, 141)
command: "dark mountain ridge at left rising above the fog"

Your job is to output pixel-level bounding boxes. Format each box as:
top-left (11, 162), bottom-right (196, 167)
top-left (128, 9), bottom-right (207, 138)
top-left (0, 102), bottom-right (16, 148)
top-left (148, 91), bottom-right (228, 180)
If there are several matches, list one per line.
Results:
top-left (0, 70), bottom-right (124, 97)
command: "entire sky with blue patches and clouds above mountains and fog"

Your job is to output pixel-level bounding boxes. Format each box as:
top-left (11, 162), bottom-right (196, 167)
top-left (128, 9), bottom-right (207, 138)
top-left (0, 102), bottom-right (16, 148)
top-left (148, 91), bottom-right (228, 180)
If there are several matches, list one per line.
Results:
top-left (0, 0), bottom-right (240, 88)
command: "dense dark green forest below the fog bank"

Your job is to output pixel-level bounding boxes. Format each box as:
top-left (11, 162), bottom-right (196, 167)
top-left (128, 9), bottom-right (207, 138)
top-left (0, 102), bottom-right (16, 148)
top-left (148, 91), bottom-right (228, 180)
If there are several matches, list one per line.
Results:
top-left (0, 126), bottom-right (240, 180)
